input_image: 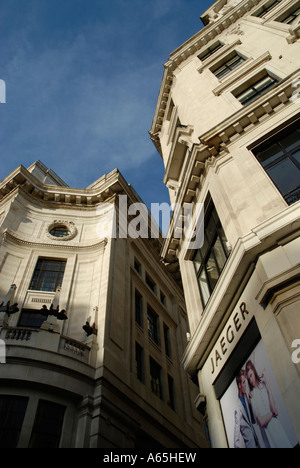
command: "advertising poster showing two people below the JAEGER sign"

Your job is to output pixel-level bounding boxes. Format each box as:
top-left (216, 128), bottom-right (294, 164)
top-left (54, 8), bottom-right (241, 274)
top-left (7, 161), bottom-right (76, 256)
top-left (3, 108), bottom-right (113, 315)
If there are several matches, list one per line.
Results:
top-left (220, 341), bottom-right (298, 448)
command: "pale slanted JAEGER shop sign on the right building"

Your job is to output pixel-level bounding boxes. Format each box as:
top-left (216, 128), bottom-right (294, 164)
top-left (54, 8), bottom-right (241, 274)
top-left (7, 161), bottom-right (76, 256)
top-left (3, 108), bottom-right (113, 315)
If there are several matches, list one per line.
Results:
top-left (210, 302), bottom-right (253, 375)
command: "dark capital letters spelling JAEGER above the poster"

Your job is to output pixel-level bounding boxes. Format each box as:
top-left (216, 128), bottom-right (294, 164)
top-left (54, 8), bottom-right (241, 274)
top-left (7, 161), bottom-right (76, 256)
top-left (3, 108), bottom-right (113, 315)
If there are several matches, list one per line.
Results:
top-left (211, 302), bottom-right (249, 374)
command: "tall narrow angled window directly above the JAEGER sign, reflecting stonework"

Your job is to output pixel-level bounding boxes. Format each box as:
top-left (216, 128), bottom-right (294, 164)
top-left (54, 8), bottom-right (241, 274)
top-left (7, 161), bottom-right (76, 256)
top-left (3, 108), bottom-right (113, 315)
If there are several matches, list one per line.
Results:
top-left (193, 203), bottom-right (229, 307)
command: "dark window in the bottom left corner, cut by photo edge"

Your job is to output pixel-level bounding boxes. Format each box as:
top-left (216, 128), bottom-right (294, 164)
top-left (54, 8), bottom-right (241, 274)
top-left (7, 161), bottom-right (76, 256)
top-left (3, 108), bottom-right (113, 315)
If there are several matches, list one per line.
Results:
top-left (0, 395), bottom-right (28, 449)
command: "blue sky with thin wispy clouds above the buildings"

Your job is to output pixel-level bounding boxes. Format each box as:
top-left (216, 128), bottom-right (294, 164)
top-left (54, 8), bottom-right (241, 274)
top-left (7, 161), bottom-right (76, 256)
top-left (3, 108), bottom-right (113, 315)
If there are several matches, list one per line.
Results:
top-left (0, 0), bottom-right (213, 206)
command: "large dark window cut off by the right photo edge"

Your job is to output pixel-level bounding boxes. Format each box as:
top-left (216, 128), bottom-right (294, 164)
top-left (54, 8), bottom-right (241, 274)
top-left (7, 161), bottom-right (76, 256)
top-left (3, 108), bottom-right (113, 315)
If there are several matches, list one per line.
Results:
top-left (252, 121), bottom-right (300, 205)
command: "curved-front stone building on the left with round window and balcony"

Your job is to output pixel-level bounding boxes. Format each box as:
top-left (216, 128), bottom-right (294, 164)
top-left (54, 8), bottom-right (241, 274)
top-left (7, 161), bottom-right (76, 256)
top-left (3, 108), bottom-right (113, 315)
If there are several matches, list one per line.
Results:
top-left (0, 161), bottom-right (208, 449)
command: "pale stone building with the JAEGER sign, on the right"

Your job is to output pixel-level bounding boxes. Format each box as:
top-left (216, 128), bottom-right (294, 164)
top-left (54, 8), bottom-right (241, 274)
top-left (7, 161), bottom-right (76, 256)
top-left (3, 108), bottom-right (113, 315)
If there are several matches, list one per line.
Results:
top-left (150, 0), bottom-right (300, 447)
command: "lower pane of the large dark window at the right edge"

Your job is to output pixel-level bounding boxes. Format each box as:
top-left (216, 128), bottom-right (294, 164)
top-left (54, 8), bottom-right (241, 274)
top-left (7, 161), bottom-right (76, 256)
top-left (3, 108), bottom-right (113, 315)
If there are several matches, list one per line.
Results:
top-left (268, 159), bottom-right (300, 195)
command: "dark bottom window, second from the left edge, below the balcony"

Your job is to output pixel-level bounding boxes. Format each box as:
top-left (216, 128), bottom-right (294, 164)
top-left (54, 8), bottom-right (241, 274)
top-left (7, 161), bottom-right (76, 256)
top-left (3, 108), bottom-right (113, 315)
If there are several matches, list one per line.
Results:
top-left (29, 400), bottom-right (66, 448)
